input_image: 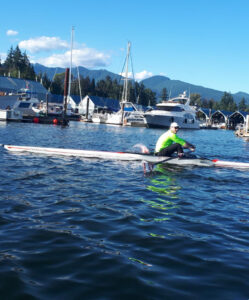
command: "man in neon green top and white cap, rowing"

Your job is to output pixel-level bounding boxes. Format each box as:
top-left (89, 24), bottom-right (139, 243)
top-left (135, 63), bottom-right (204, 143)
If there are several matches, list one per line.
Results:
top-left (155, 122), bottom-right (195, 158)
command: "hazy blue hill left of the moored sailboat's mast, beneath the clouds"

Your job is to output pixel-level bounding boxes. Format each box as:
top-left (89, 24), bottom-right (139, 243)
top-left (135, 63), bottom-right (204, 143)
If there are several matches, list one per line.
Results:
top-left (33, 64), bottom-right (121, 82)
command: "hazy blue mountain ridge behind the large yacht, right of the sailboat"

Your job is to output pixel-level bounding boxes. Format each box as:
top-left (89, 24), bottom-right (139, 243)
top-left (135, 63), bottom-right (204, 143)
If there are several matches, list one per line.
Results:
top-left (142, 76), bottom-right (249, 103)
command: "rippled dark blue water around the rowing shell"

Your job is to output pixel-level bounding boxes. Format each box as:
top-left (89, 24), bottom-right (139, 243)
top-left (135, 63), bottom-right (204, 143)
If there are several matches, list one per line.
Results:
top-left (0, 122), bottom-right (249, 299)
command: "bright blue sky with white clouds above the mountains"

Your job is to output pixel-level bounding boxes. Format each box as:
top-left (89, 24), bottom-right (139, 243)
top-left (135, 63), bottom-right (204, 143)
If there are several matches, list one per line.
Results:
top-left (0, 0), bottom-right (249, 93)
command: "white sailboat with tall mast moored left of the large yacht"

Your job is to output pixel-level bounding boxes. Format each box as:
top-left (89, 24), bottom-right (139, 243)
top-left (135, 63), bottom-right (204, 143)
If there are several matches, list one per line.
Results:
top-left (105, 42), bottom-right (146, 126)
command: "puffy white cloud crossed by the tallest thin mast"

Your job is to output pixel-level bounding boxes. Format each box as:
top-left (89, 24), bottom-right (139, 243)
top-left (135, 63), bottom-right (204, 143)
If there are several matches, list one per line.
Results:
top-left (36, 46), bottom-right (110, 68)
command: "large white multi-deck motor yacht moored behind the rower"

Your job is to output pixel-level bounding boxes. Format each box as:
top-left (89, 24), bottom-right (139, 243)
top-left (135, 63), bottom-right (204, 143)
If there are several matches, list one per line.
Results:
top-left (144, 92), bottom-right (200, 129)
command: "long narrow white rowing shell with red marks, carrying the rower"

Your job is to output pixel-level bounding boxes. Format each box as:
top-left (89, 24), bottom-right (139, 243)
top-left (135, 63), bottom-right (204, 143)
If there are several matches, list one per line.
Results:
top-left (3, 145), bottom-right (249, 168)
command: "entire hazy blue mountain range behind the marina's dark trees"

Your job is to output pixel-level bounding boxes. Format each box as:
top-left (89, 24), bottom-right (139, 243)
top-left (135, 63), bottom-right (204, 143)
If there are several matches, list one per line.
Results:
top-left (33, 63), bottom-right (249, 104)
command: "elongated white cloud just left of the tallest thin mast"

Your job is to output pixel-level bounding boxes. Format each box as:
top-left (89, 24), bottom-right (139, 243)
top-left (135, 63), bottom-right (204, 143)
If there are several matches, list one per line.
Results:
top-left (19, 36), bottom-right (70, 53)
